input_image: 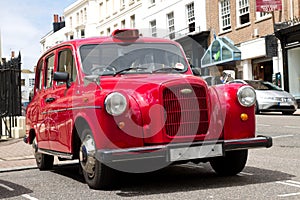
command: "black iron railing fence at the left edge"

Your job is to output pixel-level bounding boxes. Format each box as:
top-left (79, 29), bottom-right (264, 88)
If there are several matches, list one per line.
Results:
top-left (0, 54), bottom-right (22, 138)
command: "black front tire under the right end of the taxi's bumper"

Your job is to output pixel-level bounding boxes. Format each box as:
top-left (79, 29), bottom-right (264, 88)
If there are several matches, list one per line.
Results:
top-left (210, 150), bottom-right (248, 176)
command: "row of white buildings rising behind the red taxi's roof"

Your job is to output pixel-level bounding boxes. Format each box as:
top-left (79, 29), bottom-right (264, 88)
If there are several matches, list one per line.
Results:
top-left (41, 0), bottom-right (209, 69)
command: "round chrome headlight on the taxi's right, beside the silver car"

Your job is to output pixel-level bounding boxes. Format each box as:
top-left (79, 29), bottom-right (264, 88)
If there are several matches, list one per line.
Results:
top-left (237, 86), bottom-right (256, 107)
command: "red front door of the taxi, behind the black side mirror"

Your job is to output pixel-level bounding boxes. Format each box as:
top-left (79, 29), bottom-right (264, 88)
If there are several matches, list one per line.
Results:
top-left (46, 46), bottom-right (77, 153)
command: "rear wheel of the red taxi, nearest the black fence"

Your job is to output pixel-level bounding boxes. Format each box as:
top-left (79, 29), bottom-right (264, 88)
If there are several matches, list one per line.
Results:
top-left (32, 138), bottom-right (54, 171)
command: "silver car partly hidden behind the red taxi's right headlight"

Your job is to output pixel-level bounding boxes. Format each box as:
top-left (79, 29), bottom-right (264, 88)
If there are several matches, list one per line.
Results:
top-left (229, 79), bottom-right (298, 115)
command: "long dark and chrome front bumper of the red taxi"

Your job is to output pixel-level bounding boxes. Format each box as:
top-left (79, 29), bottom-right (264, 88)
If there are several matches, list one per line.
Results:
top-left (95, 136), bottom-right (273, 164)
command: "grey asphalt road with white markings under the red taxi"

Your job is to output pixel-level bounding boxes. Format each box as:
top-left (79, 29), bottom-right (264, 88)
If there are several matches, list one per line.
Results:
top-left (0, 114), bottom-right (300, 200)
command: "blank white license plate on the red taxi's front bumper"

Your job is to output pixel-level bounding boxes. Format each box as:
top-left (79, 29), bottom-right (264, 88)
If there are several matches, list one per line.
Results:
top-left (170, 144), bottom-right (223, 161)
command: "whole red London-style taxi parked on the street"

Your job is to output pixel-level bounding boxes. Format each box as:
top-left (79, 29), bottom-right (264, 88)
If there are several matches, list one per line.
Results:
top-left (24, 30), bottom-right (272, 189)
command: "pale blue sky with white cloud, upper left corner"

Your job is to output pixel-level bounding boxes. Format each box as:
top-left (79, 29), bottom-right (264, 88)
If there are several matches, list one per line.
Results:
top-left (0, 0), bottom-right (76, 70)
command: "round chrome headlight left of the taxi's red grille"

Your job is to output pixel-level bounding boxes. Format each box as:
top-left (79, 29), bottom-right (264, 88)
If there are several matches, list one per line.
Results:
top-left (104, 92), bottom-right (127, 116)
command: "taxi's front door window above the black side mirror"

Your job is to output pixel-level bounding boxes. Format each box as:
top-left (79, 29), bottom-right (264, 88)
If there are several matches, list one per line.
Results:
top-left (57, 49), bottom-right (77, 84)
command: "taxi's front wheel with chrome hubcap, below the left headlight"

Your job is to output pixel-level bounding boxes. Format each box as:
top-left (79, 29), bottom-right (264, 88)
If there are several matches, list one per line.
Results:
top-left (79, 128), bottom-right (115, 189)
